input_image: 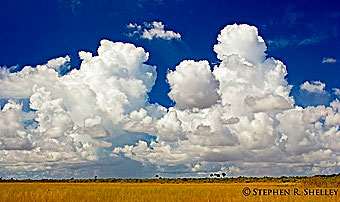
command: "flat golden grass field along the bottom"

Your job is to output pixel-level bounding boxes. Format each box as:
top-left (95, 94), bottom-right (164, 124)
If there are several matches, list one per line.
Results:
top-left (0, 182), bottom-right (340, 202)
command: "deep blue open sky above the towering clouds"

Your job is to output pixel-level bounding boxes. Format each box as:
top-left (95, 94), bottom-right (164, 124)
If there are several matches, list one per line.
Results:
top-left (0, 0), bottom-right (340, 106)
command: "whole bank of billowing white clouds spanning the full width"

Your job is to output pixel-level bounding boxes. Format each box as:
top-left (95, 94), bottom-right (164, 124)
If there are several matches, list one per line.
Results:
top-left (0, 24), bottom-right (340, 176)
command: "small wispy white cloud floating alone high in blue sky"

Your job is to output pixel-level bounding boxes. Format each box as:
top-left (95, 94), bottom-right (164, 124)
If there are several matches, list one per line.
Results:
top-left (127, 21), bottom-right (181, 40)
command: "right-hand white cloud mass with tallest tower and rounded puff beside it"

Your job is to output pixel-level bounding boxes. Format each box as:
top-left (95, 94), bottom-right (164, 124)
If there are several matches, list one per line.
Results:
top-left (112, 24), bottom-right (340, 175)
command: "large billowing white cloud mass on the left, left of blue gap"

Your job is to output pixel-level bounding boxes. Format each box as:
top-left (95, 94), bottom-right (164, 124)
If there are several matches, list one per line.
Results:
top-left (0, 40), bottom-right (156, 174)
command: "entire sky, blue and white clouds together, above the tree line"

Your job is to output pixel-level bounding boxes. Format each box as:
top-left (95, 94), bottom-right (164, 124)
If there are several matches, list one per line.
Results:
top-left (0, 0), bottom-right (340, 178)
